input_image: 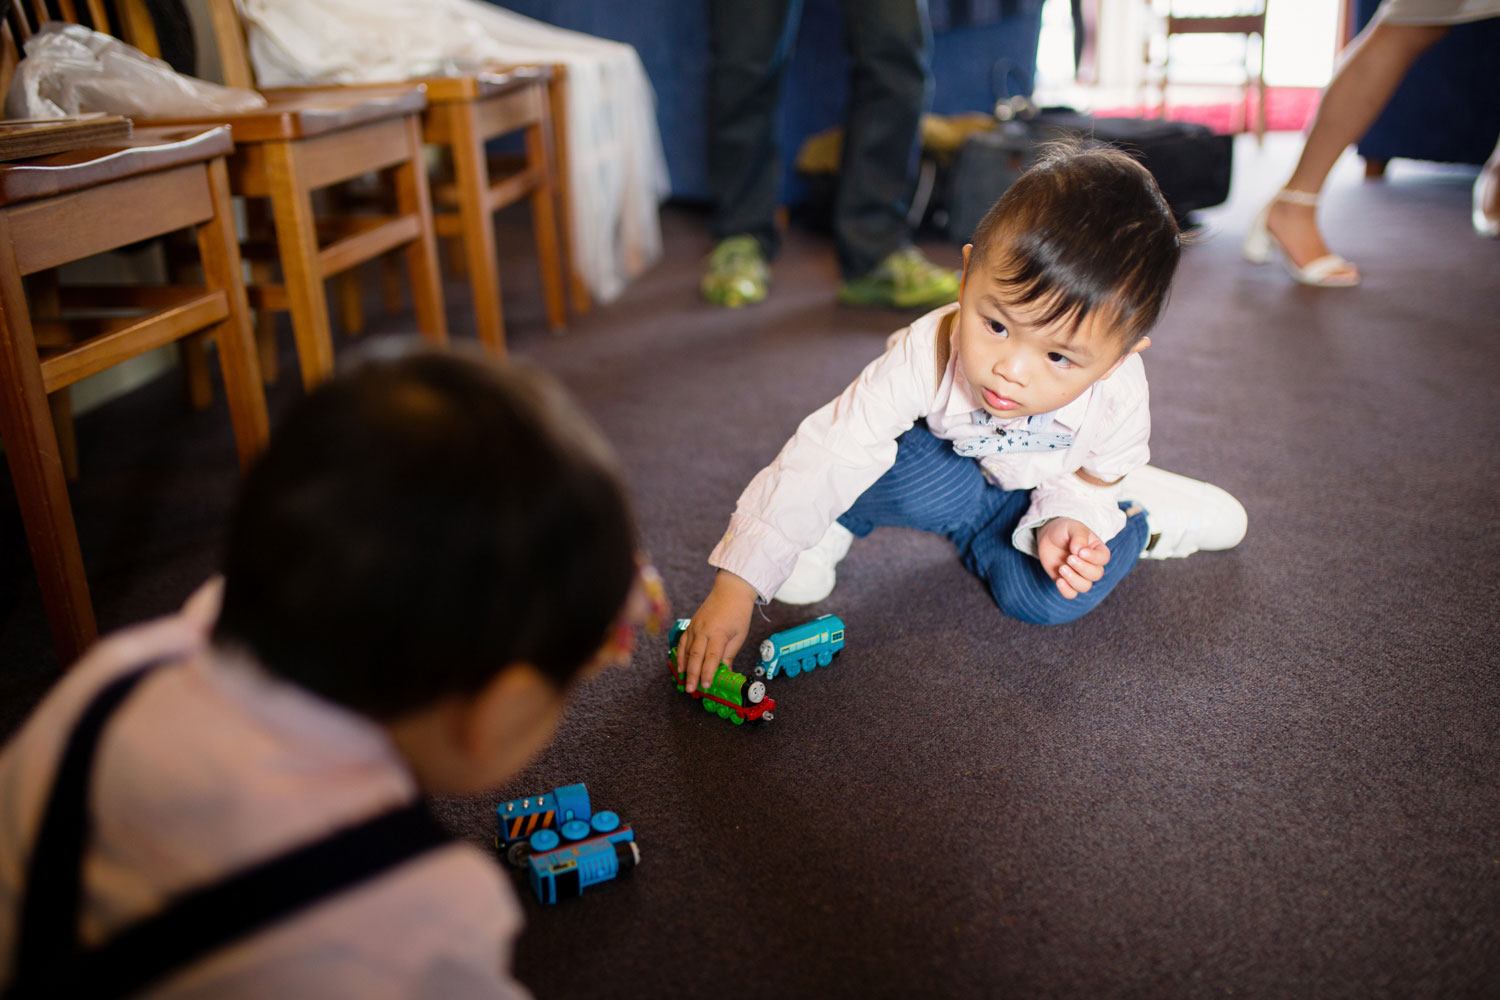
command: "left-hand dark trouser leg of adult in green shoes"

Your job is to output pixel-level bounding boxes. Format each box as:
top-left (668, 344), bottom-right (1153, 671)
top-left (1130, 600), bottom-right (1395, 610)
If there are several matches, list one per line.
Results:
top-left (708, 0), bottom-right (803, 256)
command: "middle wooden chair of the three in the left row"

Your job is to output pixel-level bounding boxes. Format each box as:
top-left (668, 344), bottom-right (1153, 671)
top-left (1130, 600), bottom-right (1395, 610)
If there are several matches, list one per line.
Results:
top-left (11, 0), bottom-right (447, 397)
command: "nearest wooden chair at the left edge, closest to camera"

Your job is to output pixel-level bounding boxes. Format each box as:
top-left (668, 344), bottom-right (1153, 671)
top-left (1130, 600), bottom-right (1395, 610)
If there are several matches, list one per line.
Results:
top-left (0, 115), bottom-right (267, 664)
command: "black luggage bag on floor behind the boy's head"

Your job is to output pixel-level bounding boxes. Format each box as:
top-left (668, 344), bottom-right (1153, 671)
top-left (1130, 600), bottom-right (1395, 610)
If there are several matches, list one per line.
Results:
top-left (944, 108), bottom-right (1235, 243)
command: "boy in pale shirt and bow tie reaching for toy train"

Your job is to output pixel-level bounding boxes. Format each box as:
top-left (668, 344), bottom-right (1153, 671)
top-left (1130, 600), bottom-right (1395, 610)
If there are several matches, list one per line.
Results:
top-left (678, 144), bottom-right (1245, 690)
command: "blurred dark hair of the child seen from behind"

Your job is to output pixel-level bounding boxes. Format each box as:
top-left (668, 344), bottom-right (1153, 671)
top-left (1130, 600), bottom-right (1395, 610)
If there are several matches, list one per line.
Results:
top-left (215, 344), bottom-right (636, 720)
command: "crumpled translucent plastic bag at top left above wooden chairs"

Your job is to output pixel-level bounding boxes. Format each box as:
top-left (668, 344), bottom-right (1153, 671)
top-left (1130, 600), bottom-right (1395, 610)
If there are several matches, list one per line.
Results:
top-left (5, 21), bottom-right (266, 118)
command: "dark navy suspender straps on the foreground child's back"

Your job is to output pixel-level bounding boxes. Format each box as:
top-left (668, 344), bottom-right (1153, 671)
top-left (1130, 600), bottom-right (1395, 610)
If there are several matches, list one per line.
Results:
top-left (3, 664), bottom-right (453, 1000)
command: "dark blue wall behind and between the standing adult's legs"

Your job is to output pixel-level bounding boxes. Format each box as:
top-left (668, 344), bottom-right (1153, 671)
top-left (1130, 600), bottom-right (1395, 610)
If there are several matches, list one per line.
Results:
top-left (486, 0), bottom-right (1041, 201)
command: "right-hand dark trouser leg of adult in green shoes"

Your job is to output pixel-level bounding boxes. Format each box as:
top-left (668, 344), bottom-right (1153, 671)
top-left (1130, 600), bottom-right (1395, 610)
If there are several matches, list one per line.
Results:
top-left (834, 0), bottom-right (932, 279)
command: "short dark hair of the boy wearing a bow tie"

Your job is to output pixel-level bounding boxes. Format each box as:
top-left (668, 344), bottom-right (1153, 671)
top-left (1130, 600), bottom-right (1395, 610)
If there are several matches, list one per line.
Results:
top-left (969, 139), bottom-right (1182, 351)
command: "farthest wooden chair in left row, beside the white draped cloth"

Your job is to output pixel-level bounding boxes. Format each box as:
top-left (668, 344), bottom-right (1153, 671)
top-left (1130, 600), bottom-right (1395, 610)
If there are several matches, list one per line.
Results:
top-left (207, 0), bottom-right (590, 354)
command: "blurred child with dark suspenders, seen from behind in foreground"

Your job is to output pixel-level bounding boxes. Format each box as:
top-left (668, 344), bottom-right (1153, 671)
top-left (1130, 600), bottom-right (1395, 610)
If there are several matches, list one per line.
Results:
top-left (0, 352), bottom-right (663, 1000)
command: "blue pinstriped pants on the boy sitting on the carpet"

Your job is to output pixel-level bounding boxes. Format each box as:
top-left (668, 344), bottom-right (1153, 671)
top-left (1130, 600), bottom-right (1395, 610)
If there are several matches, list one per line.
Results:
top-left (839, 423), bottom-right (1148, 625)
